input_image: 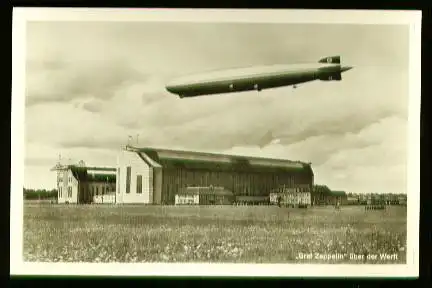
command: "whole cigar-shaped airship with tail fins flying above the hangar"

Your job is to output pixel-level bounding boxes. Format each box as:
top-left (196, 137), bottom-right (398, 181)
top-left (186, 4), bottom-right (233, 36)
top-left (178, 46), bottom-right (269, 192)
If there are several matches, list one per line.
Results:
top-left (166, 56), bottom-right (353, 98)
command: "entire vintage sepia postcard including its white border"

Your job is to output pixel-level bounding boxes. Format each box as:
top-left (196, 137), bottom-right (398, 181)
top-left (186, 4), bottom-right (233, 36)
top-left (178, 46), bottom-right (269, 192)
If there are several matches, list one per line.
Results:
top-left (11, 8), bottom-right (421, 276)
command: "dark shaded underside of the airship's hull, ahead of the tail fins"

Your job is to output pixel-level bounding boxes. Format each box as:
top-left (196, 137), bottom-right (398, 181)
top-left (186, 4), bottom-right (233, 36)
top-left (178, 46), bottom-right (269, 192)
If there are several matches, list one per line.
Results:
top-left (172, 71), bottom-right (318, 98)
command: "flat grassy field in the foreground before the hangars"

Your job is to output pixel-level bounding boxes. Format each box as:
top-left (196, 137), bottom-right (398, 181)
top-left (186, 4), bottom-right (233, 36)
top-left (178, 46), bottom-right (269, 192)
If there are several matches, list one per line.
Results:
top-left (23, 204), bottom-right (406, 264)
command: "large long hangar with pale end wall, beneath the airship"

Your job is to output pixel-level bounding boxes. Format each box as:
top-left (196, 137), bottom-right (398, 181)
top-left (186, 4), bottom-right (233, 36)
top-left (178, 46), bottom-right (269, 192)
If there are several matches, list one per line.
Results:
top-left (116, 146), bottom-right (314, 204)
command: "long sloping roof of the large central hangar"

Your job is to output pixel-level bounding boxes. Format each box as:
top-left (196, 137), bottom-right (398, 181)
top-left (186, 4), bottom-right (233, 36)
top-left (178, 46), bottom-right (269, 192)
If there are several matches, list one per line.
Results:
top-left (126, 146), bottom-right (312, 172)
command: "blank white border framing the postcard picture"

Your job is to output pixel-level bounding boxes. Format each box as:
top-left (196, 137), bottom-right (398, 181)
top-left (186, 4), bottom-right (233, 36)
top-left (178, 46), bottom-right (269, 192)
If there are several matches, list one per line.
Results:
top-left (10, 8), bottom-right (421, 277)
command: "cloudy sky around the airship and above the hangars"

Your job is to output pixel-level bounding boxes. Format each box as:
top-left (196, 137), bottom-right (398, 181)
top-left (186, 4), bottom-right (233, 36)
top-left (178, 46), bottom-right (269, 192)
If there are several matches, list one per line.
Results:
top-left (24, 22), bottom-right (409, 193)
